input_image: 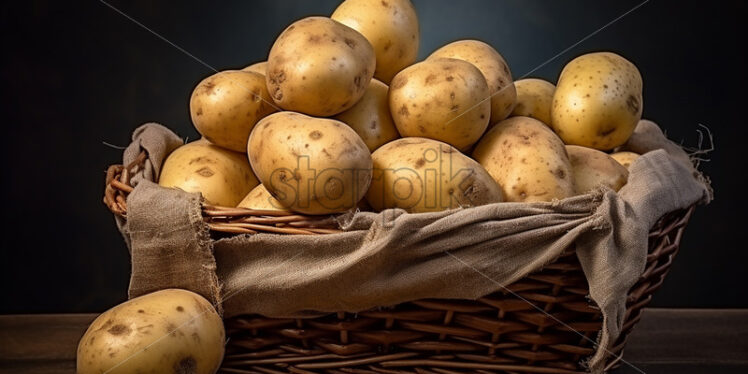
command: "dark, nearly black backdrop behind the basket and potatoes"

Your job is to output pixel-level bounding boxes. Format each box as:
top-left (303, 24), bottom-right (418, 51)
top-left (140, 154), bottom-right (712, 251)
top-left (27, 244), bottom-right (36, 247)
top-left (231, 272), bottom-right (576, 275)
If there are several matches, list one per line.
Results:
top-left (0, 0), bottom-right (748, 313)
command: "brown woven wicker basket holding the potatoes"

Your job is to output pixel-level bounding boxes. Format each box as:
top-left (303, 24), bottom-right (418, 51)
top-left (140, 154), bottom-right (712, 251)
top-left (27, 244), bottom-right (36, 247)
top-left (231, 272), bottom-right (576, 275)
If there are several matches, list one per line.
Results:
top-left (104, 153), bottom-right (694, 374)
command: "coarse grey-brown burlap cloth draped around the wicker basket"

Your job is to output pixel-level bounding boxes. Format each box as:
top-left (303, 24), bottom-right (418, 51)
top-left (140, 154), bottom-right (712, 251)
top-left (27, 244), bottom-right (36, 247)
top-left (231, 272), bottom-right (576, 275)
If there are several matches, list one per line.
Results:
top-left (118, 121), bottom-right (711, 372)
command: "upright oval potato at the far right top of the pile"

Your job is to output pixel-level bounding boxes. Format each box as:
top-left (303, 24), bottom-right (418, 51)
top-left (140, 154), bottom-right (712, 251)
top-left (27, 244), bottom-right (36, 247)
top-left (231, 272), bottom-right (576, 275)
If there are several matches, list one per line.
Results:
top-left (551, 52), bottom-right (643, 151)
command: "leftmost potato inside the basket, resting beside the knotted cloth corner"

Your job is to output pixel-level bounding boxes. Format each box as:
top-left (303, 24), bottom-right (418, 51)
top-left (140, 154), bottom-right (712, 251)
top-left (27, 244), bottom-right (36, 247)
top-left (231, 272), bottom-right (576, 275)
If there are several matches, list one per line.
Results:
top-left (158, 140), bottom-right (258, 207)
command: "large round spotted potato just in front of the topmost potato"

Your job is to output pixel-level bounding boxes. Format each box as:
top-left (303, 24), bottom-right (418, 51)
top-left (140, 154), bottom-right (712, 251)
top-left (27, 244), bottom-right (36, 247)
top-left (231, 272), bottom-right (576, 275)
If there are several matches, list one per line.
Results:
top-left (266, 17), bottom-right (376, 116)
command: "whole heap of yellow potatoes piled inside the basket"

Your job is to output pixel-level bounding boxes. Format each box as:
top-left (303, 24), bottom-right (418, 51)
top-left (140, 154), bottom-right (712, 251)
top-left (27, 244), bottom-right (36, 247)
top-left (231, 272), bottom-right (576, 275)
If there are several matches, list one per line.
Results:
top-left (159, 0), bottom-right (642, 215)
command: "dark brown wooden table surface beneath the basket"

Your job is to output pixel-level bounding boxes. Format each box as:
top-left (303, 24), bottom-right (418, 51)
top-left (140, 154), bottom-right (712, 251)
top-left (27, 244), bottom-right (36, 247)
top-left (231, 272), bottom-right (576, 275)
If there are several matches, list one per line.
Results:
top-left (0, 309), bottom-right (748, 374)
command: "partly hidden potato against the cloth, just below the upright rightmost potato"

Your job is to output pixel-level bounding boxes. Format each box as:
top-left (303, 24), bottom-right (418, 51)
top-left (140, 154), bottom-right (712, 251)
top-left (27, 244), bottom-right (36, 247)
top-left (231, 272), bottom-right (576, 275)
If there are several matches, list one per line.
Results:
top-left (566, 145), bottom-right (629, 194)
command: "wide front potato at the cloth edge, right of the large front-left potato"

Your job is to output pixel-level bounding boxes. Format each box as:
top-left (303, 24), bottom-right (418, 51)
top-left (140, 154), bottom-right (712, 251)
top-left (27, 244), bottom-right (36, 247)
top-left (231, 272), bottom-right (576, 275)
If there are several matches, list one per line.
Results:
top-left (366, 138), bottom-right (502, 213)
